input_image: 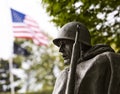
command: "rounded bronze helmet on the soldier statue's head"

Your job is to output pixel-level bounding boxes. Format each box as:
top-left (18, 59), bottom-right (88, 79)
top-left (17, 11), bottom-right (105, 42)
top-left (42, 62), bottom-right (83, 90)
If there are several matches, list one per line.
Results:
top-left (53, 22), bottom-right (91, 46)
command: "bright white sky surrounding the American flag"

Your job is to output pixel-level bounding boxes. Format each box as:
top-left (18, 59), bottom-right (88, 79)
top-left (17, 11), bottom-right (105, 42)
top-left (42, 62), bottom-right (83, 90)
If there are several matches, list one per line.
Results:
top-left (0, 0), bottom-right (57, 59)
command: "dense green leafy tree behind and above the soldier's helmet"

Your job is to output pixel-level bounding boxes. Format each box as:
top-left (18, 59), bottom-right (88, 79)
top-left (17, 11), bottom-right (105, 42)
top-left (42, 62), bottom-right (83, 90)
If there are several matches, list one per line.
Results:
top-left (42, 0), bottom-right (120, 52)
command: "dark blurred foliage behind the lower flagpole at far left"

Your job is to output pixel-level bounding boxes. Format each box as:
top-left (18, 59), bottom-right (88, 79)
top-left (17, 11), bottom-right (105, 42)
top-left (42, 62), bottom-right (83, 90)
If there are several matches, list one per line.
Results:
top-left (0, 59), bottom-right (20, 93)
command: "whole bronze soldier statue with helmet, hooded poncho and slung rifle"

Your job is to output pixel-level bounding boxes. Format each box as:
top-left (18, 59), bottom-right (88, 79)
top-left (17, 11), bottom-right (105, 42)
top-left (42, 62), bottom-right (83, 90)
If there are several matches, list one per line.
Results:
top-left (53, 22), bottom-right (120, 94)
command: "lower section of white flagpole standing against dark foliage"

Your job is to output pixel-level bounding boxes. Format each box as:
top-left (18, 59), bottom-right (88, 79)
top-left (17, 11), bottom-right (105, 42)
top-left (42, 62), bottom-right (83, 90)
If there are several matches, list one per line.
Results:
top-left (9, 57), bottom-right (15, 94)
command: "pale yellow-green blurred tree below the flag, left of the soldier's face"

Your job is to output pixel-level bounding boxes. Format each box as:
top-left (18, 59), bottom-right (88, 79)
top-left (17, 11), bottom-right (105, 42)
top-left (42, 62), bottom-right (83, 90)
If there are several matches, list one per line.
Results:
top-left (15, 37), bottom-right (63, 94)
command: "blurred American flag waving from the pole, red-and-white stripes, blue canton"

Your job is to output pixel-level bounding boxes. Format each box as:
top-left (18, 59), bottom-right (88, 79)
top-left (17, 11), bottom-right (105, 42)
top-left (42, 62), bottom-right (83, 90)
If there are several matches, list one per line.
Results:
top-left (11, 9), bottom-right (48, 45)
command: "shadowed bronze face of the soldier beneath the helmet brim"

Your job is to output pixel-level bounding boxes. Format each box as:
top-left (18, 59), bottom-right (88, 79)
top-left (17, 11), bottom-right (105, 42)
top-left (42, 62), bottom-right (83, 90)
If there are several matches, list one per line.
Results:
top-left (59, 40), bottom-right (74, 64)
